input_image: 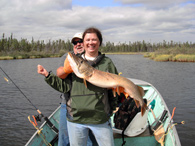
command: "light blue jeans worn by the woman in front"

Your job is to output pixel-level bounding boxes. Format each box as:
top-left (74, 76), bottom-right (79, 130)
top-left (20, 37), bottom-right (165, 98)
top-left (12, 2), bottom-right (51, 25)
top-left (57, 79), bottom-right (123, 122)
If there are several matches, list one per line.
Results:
top-left (67, 121), bottom-right (114, 146)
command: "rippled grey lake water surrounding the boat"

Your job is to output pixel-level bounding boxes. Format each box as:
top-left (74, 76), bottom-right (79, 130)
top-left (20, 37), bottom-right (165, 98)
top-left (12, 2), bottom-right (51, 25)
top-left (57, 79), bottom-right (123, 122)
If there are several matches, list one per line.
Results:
top-left (0, 55), bottom-right (195, 146)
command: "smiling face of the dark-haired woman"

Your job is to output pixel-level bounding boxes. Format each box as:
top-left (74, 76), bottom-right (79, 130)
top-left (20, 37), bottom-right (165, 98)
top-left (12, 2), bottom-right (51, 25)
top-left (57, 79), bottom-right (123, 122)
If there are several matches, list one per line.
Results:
top-left (83, 33), bottom-right (100, 55)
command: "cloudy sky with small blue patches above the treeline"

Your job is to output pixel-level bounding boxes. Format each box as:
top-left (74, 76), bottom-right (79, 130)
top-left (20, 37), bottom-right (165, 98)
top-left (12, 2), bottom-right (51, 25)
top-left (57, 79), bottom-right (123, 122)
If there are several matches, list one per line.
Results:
top-left (0, 0), bottom-right (195, 43)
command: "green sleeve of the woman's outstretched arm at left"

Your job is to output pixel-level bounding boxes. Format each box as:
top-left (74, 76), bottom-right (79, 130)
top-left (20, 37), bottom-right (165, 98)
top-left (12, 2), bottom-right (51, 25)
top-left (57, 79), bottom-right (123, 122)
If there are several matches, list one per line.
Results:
top-left (45, 73), bottom-right (71, 93)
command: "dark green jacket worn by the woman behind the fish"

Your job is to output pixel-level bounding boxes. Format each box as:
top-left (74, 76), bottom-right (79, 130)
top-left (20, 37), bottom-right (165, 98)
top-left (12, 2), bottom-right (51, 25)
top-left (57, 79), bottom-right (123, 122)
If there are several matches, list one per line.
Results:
top-left (45, 56), bottom-right (118, 124)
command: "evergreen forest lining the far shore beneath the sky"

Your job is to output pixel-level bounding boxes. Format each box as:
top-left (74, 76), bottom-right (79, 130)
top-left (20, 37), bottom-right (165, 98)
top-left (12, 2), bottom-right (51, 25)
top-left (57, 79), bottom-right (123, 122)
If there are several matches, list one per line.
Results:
top-left (0, 33), bottom-right (195, 59)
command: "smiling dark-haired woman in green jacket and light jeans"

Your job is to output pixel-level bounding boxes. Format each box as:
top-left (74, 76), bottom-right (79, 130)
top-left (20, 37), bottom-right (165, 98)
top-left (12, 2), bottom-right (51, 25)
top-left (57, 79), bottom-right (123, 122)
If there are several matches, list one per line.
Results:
top-left (37, 27), bottom-right (118, 146)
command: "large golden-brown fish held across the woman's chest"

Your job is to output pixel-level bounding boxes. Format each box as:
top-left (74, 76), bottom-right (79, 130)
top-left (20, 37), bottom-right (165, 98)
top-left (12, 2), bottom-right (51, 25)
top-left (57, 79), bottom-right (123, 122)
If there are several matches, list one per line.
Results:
top-left (67, 52), bottom-right (147, 116)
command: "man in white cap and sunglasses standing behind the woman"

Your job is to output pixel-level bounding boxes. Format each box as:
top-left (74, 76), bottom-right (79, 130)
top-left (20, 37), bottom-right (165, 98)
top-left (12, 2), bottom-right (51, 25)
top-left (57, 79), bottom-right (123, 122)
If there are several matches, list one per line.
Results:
top-left (56, 33), bottom-right (84, 146)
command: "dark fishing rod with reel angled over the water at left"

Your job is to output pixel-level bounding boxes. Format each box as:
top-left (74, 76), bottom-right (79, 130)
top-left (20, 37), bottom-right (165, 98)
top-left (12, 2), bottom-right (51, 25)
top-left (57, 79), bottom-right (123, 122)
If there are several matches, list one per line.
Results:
top-left (0, 67), bottom-right (58, 133)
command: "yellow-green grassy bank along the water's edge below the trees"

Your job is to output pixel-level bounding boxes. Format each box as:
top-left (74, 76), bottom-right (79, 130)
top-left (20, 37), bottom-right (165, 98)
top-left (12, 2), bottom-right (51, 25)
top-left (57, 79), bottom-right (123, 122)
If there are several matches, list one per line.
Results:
top-left (0, 47), bottom-right (195, 62)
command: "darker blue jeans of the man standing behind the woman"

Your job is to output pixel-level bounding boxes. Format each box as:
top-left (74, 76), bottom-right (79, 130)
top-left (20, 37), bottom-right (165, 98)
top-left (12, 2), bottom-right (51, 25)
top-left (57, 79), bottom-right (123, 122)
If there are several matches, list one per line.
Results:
top-left (58, 103), bottom-right (97, 146)
